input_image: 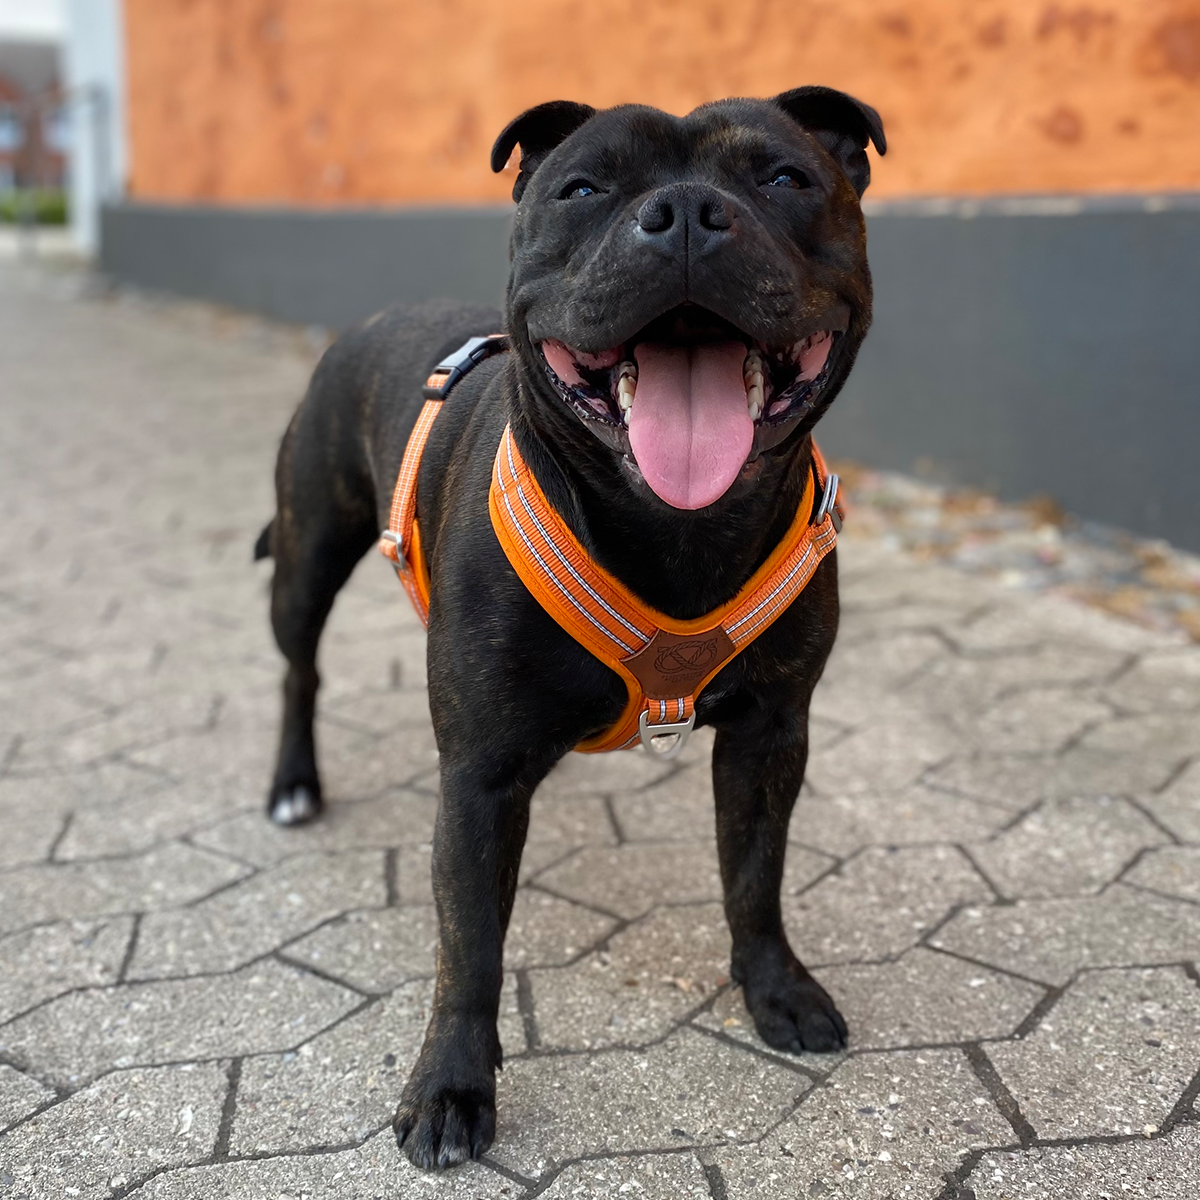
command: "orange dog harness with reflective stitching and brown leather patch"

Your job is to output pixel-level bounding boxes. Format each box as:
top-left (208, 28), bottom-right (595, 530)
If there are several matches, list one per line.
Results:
top-left (379, 335), bottom-right (841, 758)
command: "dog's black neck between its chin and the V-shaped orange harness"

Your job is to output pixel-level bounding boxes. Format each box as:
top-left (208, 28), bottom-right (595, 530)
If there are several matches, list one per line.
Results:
top-left (512, 372), bottom-right (812, 620)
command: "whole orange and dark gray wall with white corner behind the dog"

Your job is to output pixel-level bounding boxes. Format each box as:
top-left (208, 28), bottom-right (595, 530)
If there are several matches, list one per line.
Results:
top-left (9, 0), bottom-right (1200, 550)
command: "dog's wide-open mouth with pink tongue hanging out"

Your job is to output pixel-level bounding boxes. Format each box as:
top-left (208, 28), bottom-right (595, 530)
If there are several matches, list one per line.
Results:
top-left (539, 305), bottom-right (844, 509)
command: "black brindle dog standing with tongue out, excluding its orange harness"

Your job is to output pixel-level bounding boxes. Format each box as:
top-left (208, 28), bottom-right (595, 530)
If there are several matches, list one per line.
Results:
top-left (259, 88), bottom-right (884, 1168)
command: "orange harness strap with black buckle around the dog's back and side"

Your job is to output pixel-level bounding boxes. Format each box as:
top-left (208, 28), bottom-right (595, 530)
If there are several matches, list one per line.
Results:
top-left (379, 334), bottom-right (509, 625)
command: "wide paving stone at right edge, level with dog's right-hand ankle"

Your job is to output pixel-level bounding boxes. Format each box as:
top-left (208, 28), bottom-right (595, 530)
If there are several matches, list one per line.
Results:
top-left (931, 883), bottom-right (1200, 985)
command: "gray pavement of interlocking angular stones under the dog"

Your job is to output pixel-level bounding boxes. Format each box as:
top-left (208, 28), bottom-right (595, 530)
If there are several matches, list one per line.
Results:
top-left (0, 264), bottom-right (1200, 1200)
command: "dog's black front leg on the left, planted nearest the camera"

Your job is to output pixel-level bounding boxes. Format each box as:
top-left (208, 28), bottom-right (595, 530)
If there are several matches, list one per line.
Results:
top-left (392, 748), bottom-right (551, 1169)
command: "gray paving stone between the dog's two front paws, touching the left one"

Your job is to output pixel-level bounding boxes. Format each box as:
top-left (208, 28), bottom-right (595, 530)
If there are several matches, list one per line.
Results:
top-left (492, 1030), bottom-right (811, 1176)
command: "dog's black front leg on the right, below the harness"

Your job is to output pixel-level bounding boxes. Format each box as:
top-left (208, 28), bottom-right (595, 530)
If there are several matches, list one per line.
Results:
top-left (713, 704), bottom-right (846, 1054)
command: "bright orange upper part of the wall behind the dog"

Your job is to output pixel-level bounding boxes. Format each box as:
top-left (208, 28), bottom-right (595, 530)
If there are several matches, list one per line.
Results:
top-left (125, 0), bottom-right (1200, 204)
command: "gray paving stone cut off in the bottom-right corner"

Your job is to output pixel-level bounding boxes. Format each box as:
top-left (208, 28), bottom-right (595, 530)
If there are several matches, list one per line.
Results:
top-left (967, 1126), bottom-right (1200, 1200)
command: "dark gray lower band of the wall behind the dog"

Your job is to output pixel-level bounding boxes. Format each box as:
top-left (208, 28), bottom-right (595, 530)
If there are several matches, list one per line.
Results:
top-left (101, 196), bottom-right (1200, 551)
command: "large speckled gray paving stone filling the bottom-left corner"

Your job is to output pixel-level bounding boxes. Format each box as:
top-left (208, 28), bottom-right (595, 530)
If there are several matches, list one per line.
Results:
top-left (4, 1063), bottom-right (229, 1200)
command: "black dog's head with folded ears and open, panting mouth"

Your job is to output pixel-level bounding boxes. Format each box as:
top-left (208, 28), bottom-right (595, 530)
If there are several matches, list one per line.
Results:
top-left (492, 88), bottom-right (884, 509)
